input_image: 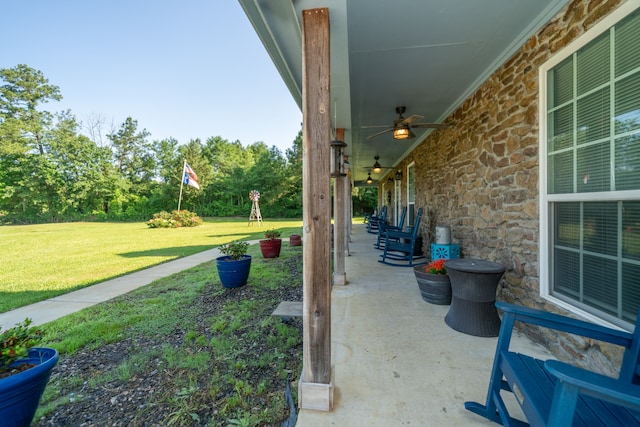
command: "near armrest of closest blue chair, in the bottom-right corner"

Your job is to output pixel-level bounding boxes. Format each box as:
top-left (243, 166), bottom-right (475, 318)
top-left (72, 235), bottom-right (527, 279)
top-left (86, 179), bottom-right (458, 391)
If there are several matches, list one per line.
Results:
top-left (544, 360), bottom-right (640, 410)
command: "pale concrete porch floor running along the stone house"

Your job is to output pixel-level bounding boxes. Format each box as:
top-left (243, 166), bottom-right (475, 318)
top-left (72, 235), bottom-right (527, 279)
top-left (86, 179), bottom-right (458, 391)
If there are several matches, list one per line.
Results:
top-left (296, 224), bottom-right (553, 427)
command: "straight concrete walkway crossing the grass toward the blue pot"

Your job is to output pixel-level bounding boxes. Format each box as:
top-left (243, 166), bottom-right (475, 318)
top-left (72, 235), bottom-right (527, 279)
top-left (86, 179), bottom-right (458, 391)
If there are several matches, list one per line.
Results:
top-left (0, 240), bottom-right (257, 329)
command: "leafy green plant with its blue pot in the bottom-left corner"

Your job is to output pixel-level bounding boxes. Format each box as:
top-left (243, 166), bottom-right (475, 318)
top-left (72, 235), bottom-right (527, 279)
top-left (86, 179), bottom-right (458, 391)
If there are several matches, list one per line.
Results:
top-left (0, 319), bottom-right (58, 427)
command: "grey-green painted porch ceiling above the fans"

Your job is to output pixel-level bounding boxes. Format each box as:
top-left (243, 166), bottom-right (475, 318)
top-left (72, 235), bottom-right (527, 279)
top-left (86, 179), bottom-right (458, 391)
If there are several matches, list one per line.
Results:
top-left (238, 0), bottom-right (569, 185)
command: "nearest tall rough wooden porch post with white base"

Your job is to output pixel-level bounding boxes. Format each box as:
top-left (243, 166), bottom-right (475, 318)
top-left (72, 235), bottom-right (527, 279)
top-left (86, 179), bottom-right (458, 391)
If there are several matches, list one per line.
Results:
top-left (298, 8), bottom-right (333, 411)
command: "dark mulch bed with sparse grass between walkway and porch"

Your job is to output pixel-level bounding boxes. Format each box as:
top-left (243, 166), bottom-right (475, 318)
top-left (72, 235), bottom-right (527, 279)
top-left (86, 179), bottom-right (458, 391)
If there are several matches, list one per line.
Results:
top-left (33, 259), bottom-right (302, 427)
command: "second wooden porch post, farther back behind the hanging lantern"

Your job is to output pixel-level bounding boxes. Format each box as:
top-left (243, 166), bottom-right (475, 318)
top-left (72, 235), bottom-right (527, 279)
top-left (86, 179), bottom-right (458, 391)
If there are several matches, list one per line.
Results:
top-left (333, 128), bottom-right (347, 285)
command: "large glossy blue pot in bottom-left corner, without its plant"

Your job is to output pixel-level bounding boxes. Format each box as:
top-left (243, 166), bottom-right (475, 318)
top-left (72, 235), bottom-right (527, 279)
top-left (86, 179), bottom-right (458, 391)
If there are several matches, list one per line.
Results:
top-left (0, 347), bottom-right (58, 427)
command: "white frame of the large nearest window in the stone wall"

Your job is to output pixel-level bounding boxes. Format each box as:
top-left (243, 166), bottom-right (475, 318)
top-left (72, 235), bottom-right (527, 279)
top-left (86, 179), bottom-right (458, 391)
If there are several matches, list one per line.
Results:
top-left (538, 0), bottom-right (640, 329)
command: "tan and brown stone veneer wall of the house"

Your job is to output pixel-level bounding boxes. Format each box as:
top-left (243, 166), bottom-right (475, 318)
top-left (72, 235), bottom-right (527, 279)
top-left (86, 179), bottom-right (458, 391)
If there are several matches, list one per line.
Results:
top-left (381, 0), bottom-right (623, 374)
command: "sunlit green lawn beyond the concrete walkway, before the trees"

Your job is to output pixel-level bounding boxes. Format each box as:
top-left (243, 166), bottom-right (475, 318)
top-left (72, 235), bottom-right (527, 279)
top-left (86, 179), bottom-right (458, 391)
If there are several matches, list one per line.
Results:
top-left (0, 218), bottom-right (302, 312)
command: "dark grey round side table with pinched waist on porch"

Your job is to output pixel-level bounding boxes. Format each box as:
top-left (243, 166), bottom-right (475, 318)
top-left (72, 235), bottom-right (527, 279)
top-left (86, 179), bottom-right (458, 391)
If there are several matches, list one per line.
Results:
top-left (444, 258), bottom-right (505, 337)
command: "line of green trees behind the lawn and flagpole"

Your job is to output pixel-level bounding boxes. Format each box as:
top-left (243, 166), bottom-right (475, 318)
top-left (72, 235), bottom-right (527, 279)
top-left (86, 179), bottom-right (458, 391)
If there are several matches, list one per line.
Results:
top-left (0, 64), bottom-right (377, 224)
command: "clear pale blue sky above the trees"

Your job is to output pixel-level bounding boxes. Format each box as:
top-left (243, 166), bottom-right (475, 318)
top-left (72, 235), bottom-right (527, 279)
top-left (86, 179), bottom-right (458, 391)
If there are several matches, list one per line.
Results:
top-left (0, 0), bottom-right (302, 153)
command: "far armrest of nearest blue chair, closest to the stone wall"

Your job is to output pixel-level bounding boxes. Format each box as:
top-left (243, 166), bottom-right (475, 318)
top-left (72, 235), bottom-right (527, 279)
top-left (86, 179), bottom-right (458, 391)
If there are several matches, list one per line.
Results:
top-left (496, 302), bottom-right (632, 348)
